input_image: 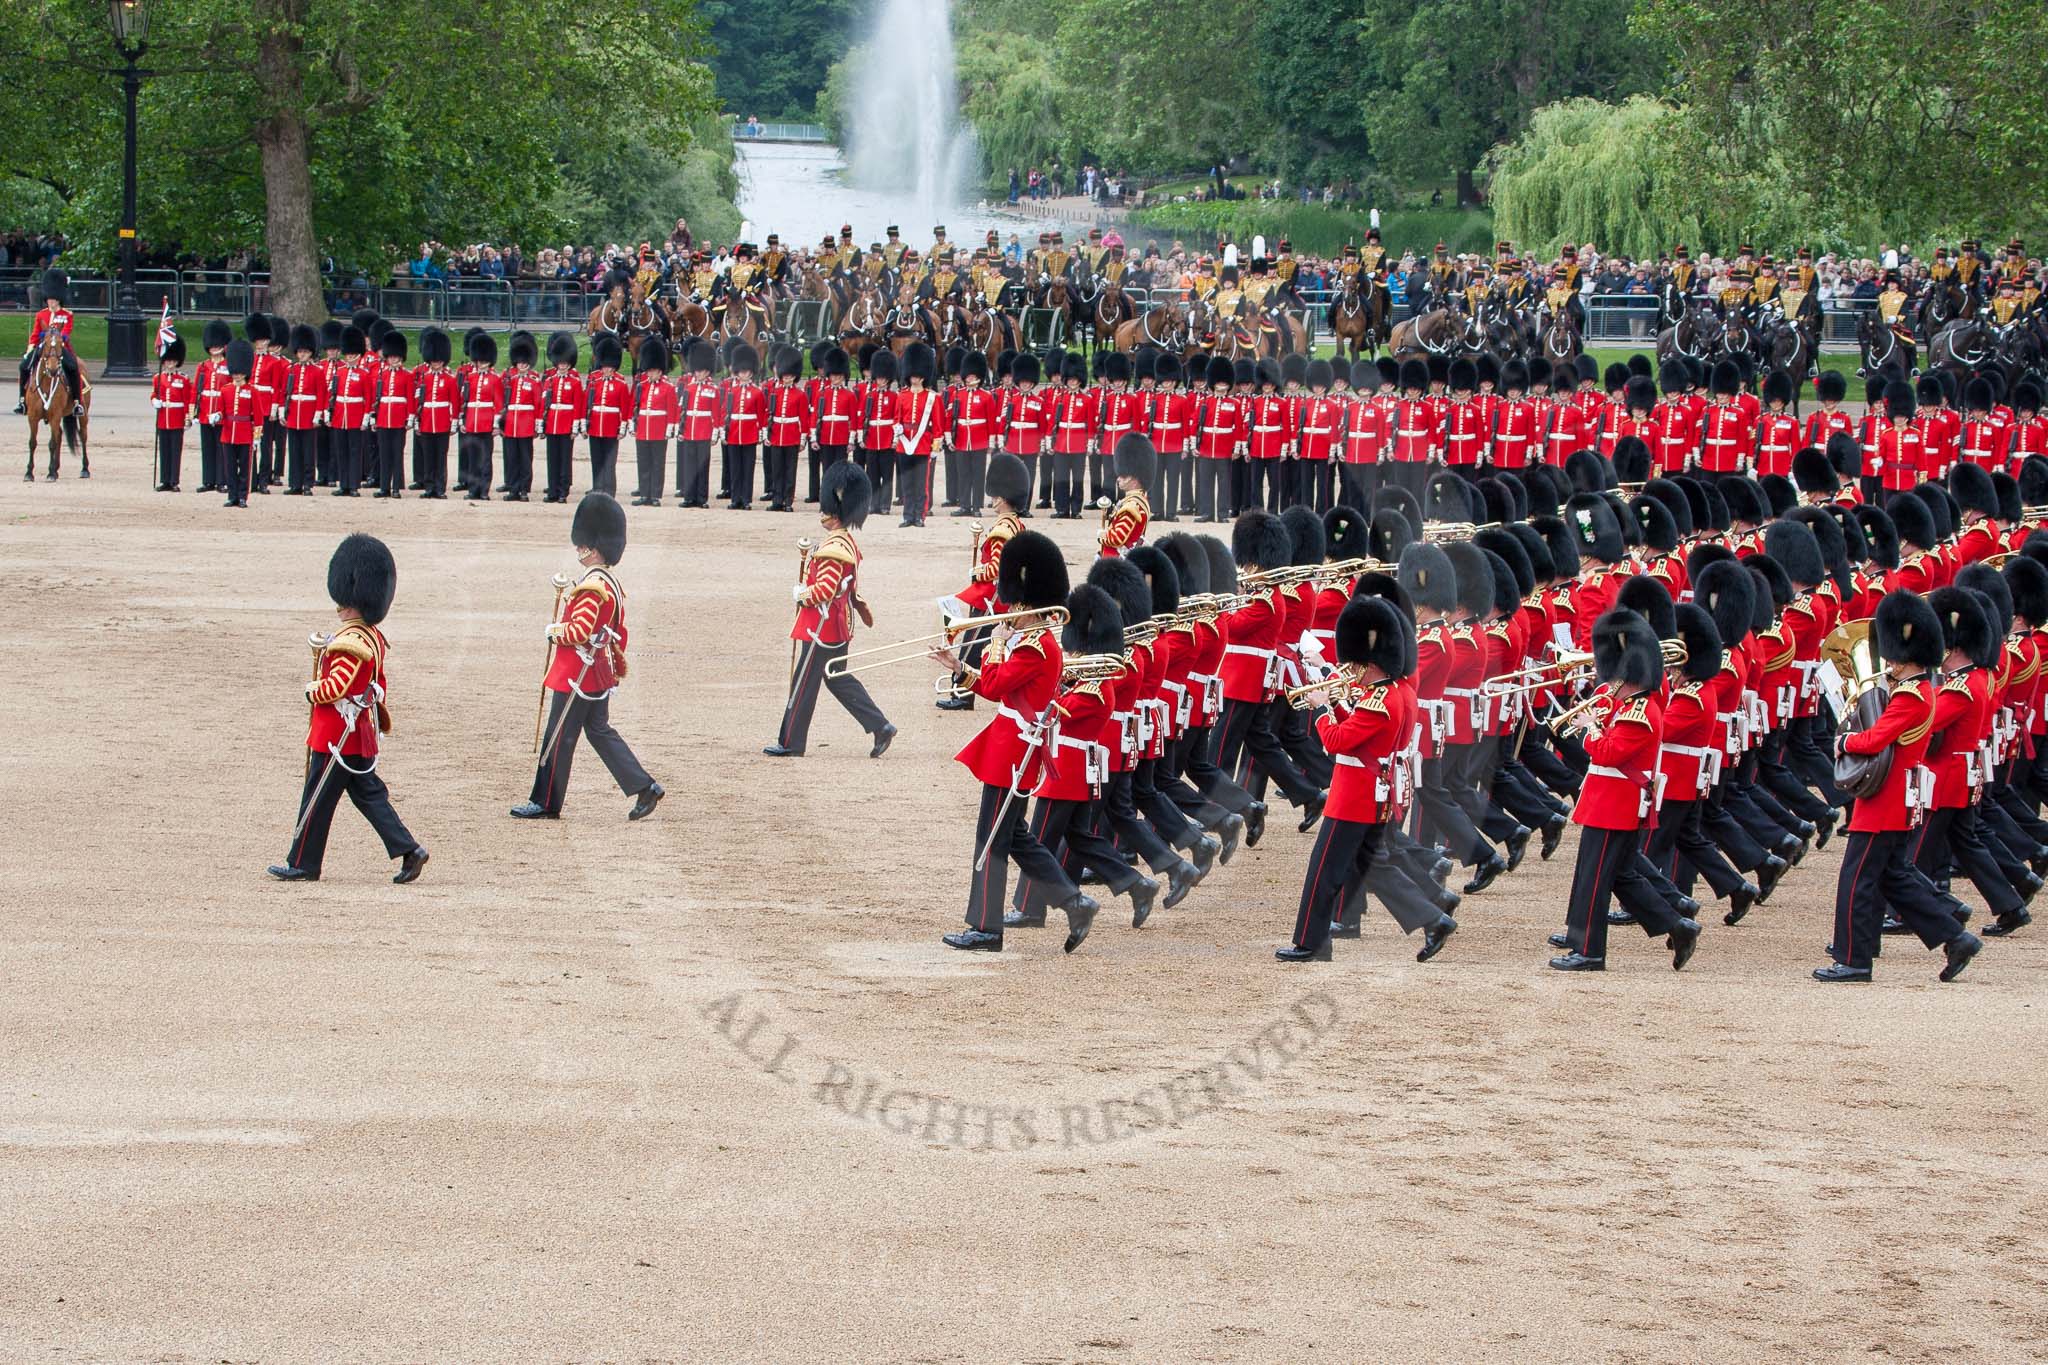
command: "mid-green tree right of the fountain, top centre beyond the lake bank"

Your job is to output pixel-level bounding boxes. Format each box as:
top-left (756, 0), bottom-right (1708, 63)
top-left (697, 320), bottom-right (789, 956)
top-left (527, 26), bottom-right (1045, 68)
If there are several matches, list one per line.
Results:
top-left (1057, 0), bottom-right (1257, 168)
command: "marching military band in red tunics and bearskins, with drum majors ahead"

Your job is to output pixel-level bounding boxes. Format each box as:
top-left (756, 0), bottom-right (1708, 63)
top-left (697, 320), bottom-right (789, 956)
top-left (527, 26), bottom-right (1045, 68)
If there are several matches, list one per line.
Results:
top-left (272, 405), bottom-right (2048, 980)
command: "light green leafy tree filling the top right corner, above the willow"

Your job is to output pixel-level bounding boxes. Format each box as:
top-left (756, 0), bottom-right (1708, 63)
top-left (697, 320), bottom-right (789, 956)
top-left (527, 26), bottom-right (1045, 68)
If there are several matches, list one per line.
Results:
top-left (1634, 0), bottom-right (2048, 233)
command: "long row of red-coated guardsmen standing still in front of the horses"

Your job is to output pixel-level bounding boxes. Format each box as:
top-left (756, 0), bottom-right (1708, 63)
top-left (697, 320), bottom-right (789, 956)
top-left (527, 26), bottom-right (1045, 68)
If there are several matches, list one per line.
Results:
top-left (154, 311), bottom-right (2048, 526)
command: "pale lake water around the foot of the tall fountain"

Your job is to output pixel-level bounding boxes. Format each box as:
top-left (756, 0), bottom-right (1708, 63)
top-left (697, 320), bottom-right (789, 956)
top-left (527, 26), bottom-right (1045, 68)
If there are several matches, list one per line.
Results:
top-left (737, 141), bottom-right (1051, 252)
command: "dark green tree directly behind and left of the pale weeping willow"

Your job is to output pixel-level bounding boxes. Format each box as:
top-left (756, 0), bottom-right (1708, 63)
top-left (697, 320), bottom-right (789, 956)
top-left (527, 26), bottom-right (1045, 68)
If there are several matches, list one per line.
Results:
top-left (1358, 0), bottom-right (1655, 205)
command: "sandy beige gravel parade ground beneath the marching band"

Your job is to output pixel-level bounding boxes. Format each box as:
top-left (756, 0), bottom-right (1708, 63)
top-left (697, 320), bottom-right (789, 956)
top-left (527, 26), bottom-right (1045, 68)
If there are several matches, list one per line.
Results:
top-left (0, 387), bottom-right (2048, 1361)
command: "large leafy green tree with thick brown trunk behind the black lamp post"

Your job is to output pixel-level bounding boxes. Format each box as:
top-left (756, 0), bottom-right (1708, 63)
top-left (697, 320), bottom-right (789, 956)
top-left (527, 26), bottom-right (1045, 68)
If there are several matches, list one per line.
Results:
top-left (0, 0), bottom-right (711, 317)
